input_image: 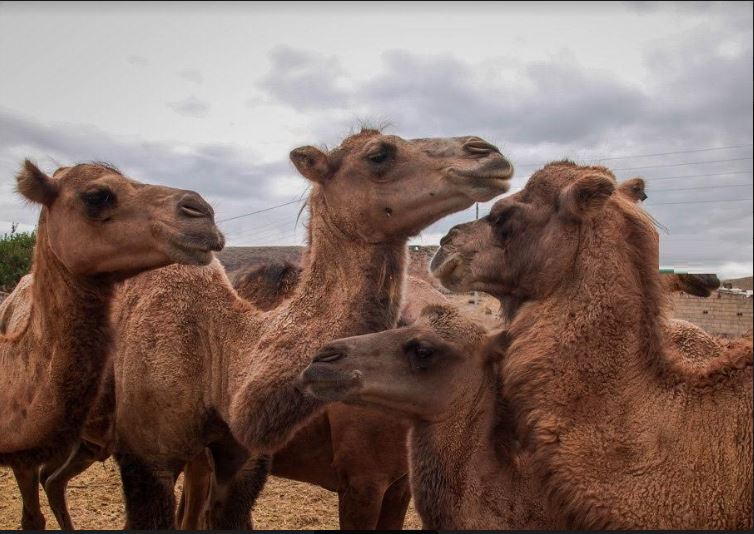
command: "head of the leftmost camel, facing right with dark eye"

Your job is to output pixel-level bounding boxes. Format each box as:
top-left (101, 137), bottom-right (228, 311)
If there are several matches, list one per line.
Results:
top-left (16, 160), bottom-right (224, 275)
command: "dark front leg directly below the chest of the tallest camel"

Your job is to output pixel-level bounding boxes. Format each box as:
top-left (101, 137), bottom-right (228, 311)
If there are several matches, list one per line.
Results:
top-left (204, 438), bottom-right (269, 530)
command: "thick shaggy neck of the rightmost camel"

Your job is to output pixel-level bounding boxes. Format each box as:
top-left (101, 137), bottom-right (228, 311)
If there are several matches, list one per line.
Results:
top-left (501, 219), bottom-right (678, 528)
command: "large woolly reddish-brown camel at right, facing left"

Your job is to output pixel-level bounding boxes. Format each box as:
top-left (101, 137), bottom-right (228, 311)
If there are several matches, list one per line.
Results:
top-left (426, 162), bottom-right (752, 529)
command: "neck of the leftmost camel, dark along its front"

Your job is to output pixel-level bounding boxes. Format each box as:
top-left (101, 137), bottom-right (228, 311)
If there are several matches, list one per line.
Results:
top-left (0, 216), bottom-right (112, 455)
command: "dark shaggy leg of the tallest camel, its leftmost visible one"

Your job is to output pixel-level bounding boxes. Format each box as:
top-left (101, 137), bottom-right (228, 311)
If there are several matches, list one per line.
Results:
top-left (115, 453), bottom-right (179, 530)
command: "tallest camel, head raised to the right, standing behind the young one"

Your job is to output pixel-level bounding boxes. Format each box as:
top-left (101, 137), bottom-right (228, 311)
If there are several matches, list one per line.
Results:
top-left (115, 131), bottom-right (512, 528)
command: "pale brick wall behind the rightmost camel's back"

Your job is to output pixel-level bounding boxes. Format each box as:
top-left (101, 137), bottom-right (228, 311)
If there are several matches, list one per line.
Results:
top-left (673, 291), bottom-right (752, 337)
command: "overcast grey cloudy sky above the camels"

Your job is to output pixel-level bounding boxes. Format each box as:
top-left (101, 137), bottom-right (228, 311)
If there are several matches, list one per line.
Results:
top-left (0, 2), bottom-right (754, 277)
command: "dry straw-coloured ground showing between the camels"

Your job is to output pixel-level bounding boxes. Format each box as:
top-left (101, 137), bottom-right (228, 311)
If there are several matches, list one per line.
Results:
top-left (0, 294), bottom-right (498, 530)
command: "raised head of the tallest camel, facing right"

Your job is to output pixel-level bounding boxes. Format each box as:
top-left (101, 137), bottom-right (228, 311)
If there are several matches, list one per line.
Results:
top-left (290, 130), bottom-right (513, 243)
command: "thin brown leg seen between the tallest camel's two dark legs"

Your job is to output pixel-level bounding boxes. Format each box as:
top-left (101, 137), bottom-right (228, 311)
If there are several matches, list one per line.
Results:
top-left (176, 449), bottom-right (213, 530)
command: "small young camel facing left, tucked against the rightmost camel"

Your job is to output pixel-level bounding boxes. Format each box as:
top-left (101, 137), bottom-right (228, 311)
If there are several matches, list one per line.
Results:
top-left (302, 306), bottom-right (560, 530)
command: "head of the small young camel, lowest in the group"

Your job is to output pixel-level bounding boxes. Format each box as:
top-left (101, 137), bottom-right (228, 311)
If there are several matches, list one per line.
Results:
top-left (300, 305), bottom-right (486, 420)
